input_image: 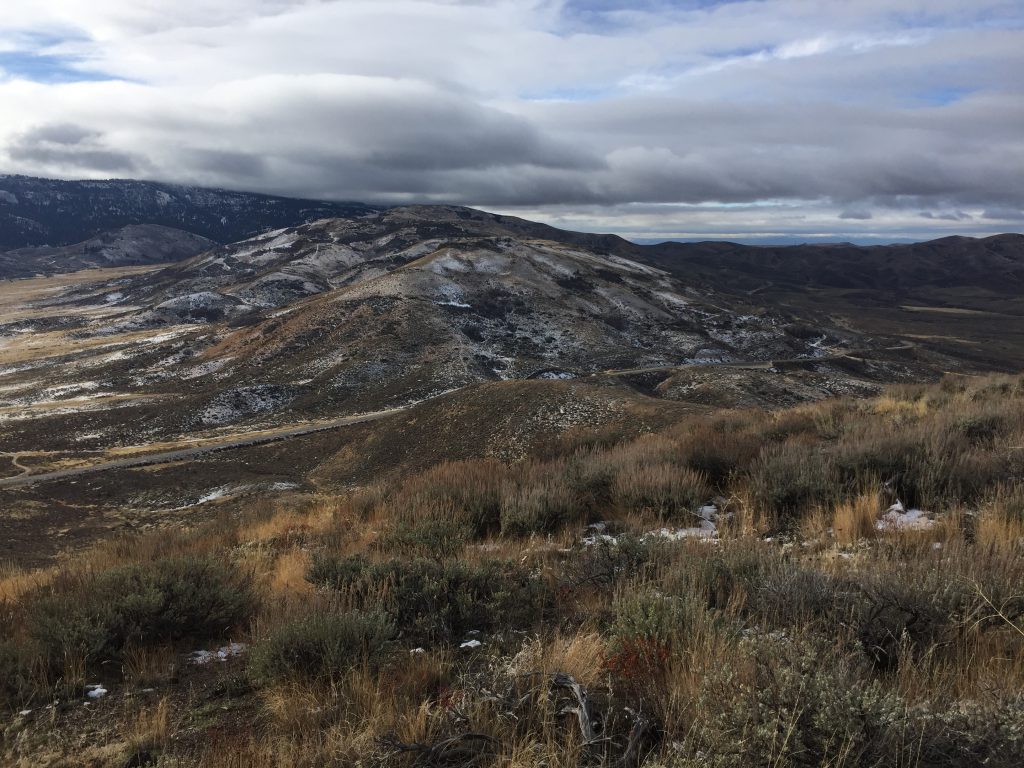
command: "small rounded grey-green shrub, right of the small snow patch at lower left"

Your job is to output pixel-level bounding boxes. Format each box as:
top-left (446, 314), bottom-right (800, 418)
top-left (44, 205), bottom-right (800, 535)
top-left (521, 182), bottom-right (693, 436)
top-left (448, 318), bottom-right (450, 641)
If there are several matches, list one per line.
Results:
top-left (249, 611), bottom-right (395, 684)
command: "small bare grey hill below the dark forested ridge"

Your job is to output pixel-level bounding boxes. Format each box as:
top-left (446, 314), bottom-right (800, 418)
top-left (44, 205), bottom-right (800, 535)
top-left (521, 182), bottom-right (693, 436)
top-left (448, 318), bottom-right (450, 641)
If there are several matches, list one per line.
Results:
top-left (0, 224), bottom-right (217, 280)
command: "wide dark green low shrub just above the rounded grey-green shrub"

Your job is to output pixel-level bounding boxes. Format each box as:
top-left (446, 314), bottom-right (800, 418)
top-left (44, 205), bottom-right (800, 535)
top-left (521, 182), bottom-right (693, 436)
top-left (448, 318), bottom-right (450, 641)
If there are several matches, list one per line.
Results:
top-left (307, 557), bottom-right (551, 642)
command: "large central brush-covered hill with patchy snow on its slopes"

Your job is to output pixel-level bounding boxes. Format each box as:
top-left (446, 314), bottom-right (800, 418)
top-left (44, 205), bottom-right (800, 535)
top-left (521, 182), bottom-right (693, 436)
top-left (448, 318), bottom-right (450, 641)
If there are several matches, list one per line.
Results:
top-left (0, 208), bottom-right (867, 442)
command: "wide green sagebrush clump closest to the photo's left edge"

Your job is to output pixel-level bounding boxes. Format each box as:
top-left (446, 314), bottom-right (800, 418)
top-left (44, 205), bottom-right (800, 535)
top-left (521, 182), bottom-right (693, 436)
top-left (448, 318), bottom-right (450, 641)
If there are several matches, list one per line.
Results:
top-left (28, 557), bottom-right (255, 664)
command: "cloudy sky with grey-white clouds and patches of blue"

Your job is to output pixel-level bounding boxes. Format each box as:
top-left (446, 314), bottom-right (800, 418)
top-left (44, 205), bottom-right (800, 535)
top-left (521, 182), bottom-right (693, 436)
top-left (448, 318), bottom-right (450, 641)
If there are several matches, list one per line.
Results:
top-left (0, 0), bottom-right (1024, 243)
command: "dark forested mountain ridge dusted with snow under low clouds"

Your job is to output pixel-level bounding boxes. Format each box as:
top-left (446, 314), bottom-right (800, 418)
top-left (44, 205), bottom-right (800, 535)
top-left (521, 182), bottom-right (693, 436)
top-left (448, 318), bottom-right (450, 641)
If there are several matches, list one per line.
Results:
top-left (0, 176), bottom-right (377, 251)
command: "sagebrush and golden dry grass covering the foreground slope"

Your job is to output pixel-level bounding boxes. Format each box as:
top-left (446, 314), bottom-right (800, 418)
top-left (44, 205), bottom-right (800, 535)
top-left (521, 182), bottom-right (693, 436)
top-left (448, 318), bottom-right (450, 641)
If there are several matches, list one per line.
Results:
top-left (0, 377), bottom-right (1024, 768)
